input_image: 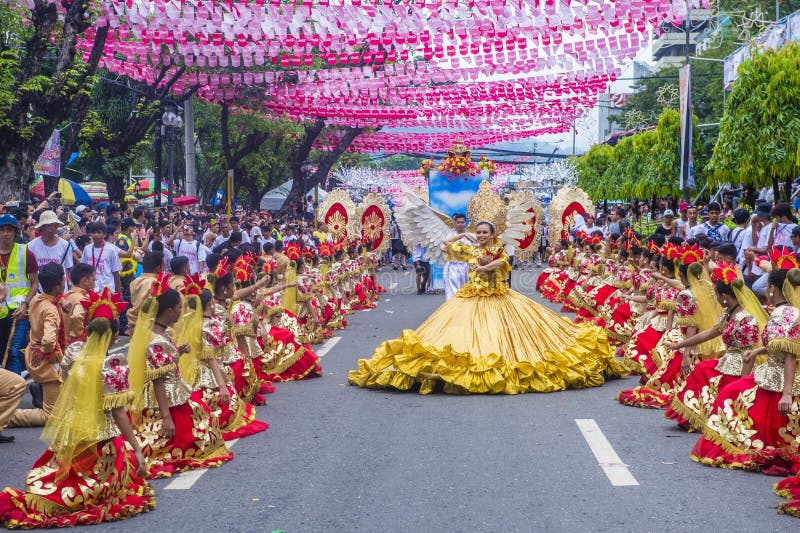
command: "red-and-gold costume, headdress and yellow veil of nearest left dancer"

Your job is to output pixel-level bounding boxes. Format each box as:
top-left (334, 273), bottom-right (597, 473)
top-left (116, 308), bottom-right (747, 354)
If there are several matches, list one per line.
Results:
top-left (0, 289), bottom-right (155, 529)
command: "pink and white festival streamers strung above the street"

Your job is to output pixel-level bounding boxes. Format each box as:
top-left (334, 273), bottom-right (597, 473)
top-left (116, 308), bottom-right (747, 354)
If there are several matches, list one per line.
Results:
top-left (14, 0), bottom-right (707, 152)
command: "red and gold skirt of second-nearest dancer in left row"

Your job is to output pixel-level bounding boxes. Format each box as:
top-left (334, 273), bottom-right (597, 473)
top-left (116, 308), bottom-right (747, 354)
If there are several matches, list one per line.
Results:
top-left (136, 399), bottom-right (233, 479)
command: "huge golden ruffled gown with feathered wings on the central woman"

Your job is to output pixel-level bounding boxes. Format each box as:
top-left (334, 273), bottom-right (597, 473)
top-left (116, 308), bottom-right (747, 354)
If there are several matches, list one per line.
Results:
top-left (348, 182), bottom-right (626, 394)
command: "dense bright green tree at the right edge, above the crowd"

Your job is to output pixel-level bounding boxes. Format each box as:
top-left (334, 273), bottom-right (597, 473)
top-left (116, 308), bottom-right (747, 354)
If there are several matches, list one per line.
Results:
top-left (710, 43), bottom-right (800, 198)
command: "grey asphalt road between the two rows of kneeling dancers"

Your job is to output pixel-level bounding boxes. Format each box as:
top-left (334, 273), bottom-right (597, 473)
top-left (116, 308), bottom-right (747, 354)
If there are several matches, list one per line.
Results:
top-left (0, 270), bottom-right (800, 533)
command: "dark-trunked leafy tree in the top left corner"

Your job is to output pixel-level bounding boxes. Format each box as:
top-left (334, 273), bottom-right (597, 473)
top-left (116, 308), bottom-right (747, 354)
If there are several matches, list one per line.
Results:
top-left (0, 0), bottom-right (108, 199)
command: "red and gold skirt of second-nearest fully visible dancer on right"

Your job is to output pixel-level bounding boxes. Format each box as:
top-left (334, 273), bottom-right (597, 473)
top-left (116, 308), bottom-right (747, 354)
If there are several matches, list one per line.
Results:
top-left (664, 359), bottom-right (740, 431)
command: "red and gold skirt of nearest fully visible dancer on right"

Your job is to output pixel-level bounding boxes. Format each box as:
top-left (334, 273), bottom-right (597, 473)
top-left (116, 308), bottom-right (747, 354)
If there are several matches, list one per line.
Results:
top-left (692, 374), bottom-right (800, 475)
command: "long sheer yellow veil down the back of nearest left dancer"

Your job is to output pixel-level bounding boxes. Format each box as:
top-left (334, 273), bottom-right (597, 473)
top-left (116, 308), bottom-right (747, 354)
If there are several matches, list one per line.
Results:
top-left (40, 319), bottom-right (112, 479)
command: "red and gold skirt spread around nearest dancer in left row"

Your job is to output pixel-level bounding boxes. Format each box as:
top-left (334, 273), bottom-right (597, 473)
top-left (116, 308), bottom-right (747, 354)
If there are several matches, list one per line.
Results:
top-left (0, 436), bottom-right (156, 529)
